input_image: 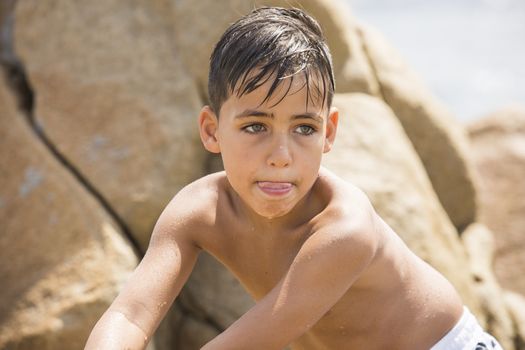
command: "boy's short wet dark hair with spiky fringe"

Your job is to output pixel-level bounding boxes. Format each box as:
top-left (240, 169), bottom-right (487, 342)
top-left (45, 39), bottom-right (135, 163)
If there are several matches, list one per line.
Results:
top-left (208, 7), bottom-right (335, 116)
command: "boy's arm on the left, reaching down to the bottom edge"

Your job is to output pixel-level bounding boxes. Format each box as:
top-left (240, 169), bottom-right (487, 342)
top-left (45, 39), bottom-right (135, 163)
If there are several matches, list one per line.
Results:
top-left (85, 200), bottom-right (199, 350)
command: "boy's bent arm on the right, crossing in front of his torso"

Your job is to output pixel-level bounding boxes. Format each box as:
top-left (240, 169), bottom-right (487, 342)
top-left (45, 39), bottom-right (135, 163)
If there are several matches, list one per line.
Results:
top-left (202, 223), bottom-right (376, 350)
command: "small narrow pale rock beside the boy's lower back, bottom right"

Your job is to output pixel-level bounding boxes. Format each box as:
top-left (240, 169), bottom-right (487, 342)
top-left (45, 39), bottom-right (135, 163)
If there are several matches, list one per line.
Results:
top-left (461, 223), bottom-right (514, 349)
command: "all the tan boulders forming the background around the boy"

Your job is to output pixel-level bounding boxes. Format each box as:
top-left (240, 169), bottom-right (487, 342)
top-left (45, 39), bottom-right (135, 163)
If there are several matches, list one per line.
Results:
top-left (0, 0), bottom-right (525, 350)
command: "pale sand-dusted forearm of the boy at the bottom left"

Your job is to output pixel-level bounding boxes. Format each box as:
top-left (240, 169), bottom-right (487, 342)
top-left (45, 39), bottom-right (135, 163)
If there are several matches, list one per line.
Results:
top-left (84, 309), bottom-right (149, 350)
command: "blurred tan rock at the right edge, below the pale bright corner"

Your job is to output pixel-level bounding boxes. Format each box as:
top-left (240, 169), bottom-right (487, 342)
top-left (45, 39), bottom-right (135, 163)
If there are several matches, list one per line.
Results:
top-left (468, 107), bottom-right (525, 294)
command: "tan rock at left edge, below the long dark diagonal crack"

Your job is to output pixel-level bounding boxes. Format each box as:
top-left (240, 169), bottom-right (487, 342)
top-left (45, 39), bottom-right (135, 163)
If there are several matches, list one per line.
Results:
top-left (0, 72), bottom-right (137, 350)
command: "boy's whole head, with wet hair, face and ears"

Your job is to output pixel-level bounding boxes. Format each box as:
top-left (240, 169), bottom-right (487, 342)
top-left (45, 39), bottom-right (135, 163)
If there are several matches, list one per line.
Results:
top-left (199, 8), bottom-right (338, 218)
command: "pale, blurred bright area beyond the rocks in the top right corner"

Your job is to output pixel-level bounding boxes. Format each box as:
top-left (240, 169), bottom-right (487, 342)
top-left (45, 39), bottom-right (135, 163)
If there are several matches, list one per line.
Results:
top-left (344, 0), bottom-right (525, 123)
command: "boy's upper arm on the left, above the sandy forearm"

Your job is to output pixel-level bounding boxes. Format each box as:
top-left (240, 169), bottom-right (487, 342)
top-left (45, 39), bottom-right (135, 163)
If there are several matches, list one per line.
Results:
top-left (109, 198), bottom-right (200, 338)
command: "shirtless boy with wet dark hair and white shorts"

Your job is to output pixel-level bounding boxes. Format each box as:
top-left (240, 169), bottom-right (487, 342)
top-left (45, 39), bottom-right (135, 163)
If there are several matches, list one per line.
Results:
top-left (86, 8), bottom-right (504, 350)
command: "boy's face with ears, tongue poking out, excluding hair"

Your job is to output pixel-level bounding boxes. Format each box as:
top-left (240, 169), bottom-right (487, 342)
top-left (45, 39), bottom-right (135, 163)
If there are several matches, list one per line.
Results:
top-left (199, 76), bottom-right (338, 218)
